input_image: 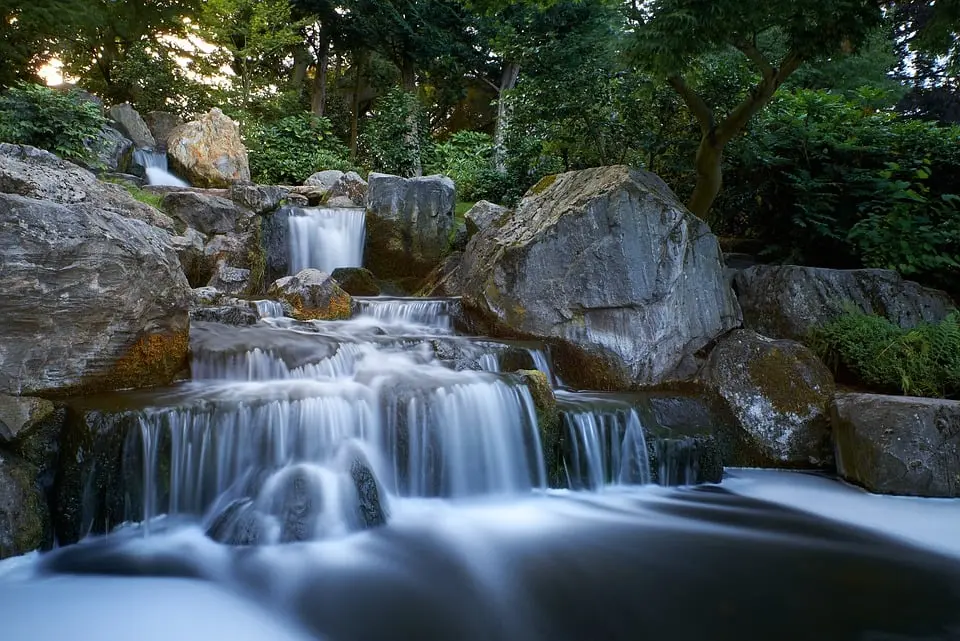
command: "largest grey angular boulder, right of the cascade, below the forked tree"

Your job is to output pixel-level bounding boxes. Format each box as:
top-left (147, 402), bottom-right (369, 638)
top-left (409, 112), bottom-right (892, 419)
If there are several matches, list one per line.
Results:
top-left (462, 166), bottom-right (740, 389)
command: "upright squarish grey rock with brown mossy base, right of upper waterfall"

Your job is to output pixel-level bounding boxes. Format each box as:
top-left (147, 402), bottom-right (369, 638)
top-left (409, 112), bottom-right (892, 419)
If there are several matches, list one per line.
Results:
top-left (364, 174), bottom-right (456, 280)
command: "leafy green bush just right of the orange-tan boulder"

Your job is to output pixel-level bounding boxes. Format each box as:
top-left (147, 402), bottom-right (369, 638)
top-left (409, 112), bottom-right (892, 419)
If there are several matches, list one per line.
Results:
top-left (244, 113), bottom-right (352, 185)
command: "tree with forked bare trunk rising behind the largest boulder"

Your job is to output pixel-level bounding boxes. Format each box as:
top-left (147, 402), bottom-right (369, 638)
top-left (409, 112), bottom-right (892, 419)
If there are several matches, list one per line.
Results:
top-left (631, 0), bottom-right (882, 217)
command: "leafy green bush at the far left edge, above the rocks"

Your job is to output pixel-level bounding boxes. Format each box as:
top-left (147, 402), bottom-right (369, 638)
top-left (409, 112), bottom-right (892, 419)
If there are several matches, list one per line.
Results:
top-left (0, 83), bottom-right (106, 161)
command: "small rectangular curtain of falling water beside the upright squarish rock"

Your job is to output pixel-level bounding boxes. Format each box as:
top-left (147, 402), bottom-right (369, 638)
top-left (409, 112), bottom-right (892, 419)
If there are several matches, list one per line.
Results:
top-left (288, 208), bottom-right (365, 274)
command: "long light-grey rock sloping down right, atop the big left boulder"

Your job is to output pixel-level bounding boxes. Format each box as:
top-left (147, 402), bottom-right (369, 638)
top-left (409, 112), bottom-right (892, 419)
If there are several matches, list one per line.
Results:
top-left (0, 144), bottom-right (174, 232)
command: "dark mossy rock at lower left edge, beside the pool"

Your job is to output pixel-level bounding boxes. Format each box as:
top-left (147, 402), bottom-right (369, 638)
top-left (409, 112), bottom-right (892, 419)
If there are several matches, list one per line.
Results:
top-left (0, 452), bottom-right (50, 559)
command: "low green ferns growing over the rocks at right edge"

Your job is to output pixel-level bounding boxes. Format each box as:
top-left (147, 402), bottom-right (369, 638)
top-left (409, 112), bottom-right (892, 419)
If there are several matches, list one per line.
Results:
top-left (811, 311), bottom-right (960, 398)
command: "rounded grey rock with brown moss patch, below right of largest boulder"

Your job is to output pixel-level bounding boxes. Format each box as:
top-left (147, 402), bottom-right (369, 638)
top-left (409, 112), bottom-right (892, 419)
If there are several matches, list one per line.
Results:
top-left (701, 330), bottom-right (835, 468)
